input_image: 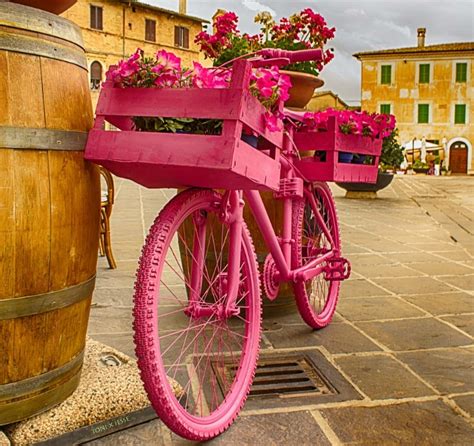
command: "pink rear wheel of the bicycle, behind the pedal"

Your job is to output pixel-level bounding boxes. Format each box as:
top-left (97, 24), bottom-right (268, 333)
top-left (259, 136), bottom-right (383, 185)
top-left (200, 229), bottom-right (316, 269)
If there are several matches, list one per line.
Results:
top-left (292, 183), bottom-right (341, 329)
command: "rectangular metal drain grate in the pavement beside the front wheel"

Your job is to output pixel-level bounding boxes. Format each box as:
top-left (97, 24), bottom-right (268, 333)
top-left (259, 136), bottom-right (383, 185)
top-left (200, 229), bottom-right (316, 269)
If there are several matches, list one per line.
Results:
top-left (212, 349), bottom-right (362, 409)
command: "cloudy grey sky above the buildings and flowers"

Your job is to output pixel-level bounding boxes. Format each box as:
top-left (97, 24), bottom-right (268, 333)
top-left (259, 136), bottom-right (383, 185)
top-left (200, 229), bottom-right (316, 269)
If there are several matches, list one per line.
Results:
top-left (146, 0), bottom-right (474, 104)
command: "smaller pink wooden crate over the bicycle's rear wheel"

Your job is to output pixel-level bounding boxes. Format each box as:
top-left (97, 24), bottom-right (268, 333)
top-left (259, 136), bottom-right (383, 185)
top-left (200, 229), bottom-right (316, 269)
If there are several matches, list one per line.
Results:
top-left (294, 117), bottom-right (382, 183)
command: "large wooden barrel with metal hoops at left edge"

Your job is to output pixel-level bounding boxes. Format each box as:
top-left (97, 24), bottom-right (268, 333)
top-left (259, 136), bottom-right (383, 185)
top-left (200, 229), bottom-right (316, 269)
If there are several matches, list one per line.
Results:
top-left (0, 2), bottom-right (100, 425)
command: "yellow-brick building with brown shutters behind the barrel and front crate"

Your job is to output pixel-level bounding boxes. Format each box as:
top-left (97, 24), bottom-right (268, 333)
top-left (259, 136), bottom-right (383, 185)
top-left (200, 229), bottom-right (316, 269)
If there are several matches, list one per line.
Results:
top-left (62, 0), bottom-right (207, 109)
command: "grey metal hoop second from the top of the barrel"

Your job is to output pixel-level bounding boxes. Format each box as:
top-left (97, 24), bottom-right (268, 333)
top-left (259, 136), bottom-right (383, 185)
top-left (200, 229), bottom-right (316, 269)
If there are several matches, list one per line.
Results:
top-left (0, 31), bottom-right (87, 70)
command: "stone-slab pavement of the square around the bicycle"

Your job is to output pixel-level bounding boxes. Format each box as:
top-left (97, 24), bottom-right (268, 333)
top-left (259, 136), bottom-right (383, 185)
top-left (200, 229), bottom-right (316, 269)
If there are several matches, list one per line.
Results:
top-left (89, 177), bottom-right (474, 445)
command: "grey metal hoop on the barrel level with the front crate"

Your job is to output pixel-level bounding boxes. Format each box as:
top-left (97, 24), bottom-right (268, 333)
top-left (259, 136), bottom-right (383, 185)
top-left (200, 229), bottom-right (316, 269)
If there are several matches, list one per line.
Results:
top-left (0, 127), bottom-right (87, 151)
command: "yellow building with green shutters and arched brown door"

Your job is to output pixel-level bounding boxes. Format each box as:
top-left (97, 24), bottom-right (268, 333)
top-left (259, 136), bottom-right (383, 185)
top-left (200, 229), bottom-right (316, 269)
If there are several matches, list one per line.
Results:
top-left (354, 28), bottom-right (474, 173)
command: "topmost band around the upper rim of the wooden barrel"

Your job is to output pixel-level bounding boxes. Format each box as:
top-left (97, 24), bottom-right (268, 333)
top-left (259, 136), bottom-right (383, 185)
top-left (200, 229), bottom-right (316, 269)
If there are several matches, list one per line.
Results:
top-left (0, 2), bottom-right (84, 48)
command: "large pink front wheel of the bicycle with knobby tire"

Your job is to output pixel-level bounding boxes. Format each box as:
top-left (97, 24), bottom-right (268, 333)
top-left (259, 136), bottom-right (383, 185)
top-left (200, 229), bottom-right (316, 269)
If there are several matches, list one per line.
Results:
top-left (134, 189), bottom-right (261, 441)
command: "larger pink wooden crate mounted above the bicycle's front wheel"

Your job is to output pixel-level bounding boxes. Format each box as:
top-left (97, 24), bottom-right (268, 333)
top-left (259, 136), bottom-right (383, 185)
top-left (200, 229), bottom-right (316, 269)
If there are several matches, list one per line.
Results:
top-left (85, 61), bottom-right (282, 190)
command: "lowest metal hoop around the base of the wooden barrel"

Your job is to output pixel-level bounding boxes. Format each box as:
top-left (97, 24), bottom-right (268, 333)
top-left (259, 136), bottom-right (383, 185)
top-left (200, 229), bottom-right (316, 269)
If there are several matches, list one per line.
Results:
top-left (0, 350), bottom-right (84, 407)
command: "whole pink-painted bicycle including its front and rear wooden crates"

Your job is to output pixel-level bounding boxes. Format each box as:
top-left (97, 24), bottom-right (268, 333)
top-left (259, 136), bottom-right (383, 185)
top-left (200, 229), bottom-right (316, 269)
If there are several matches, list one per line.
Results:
top-left (86, 50), bottom-right (380, 440)
